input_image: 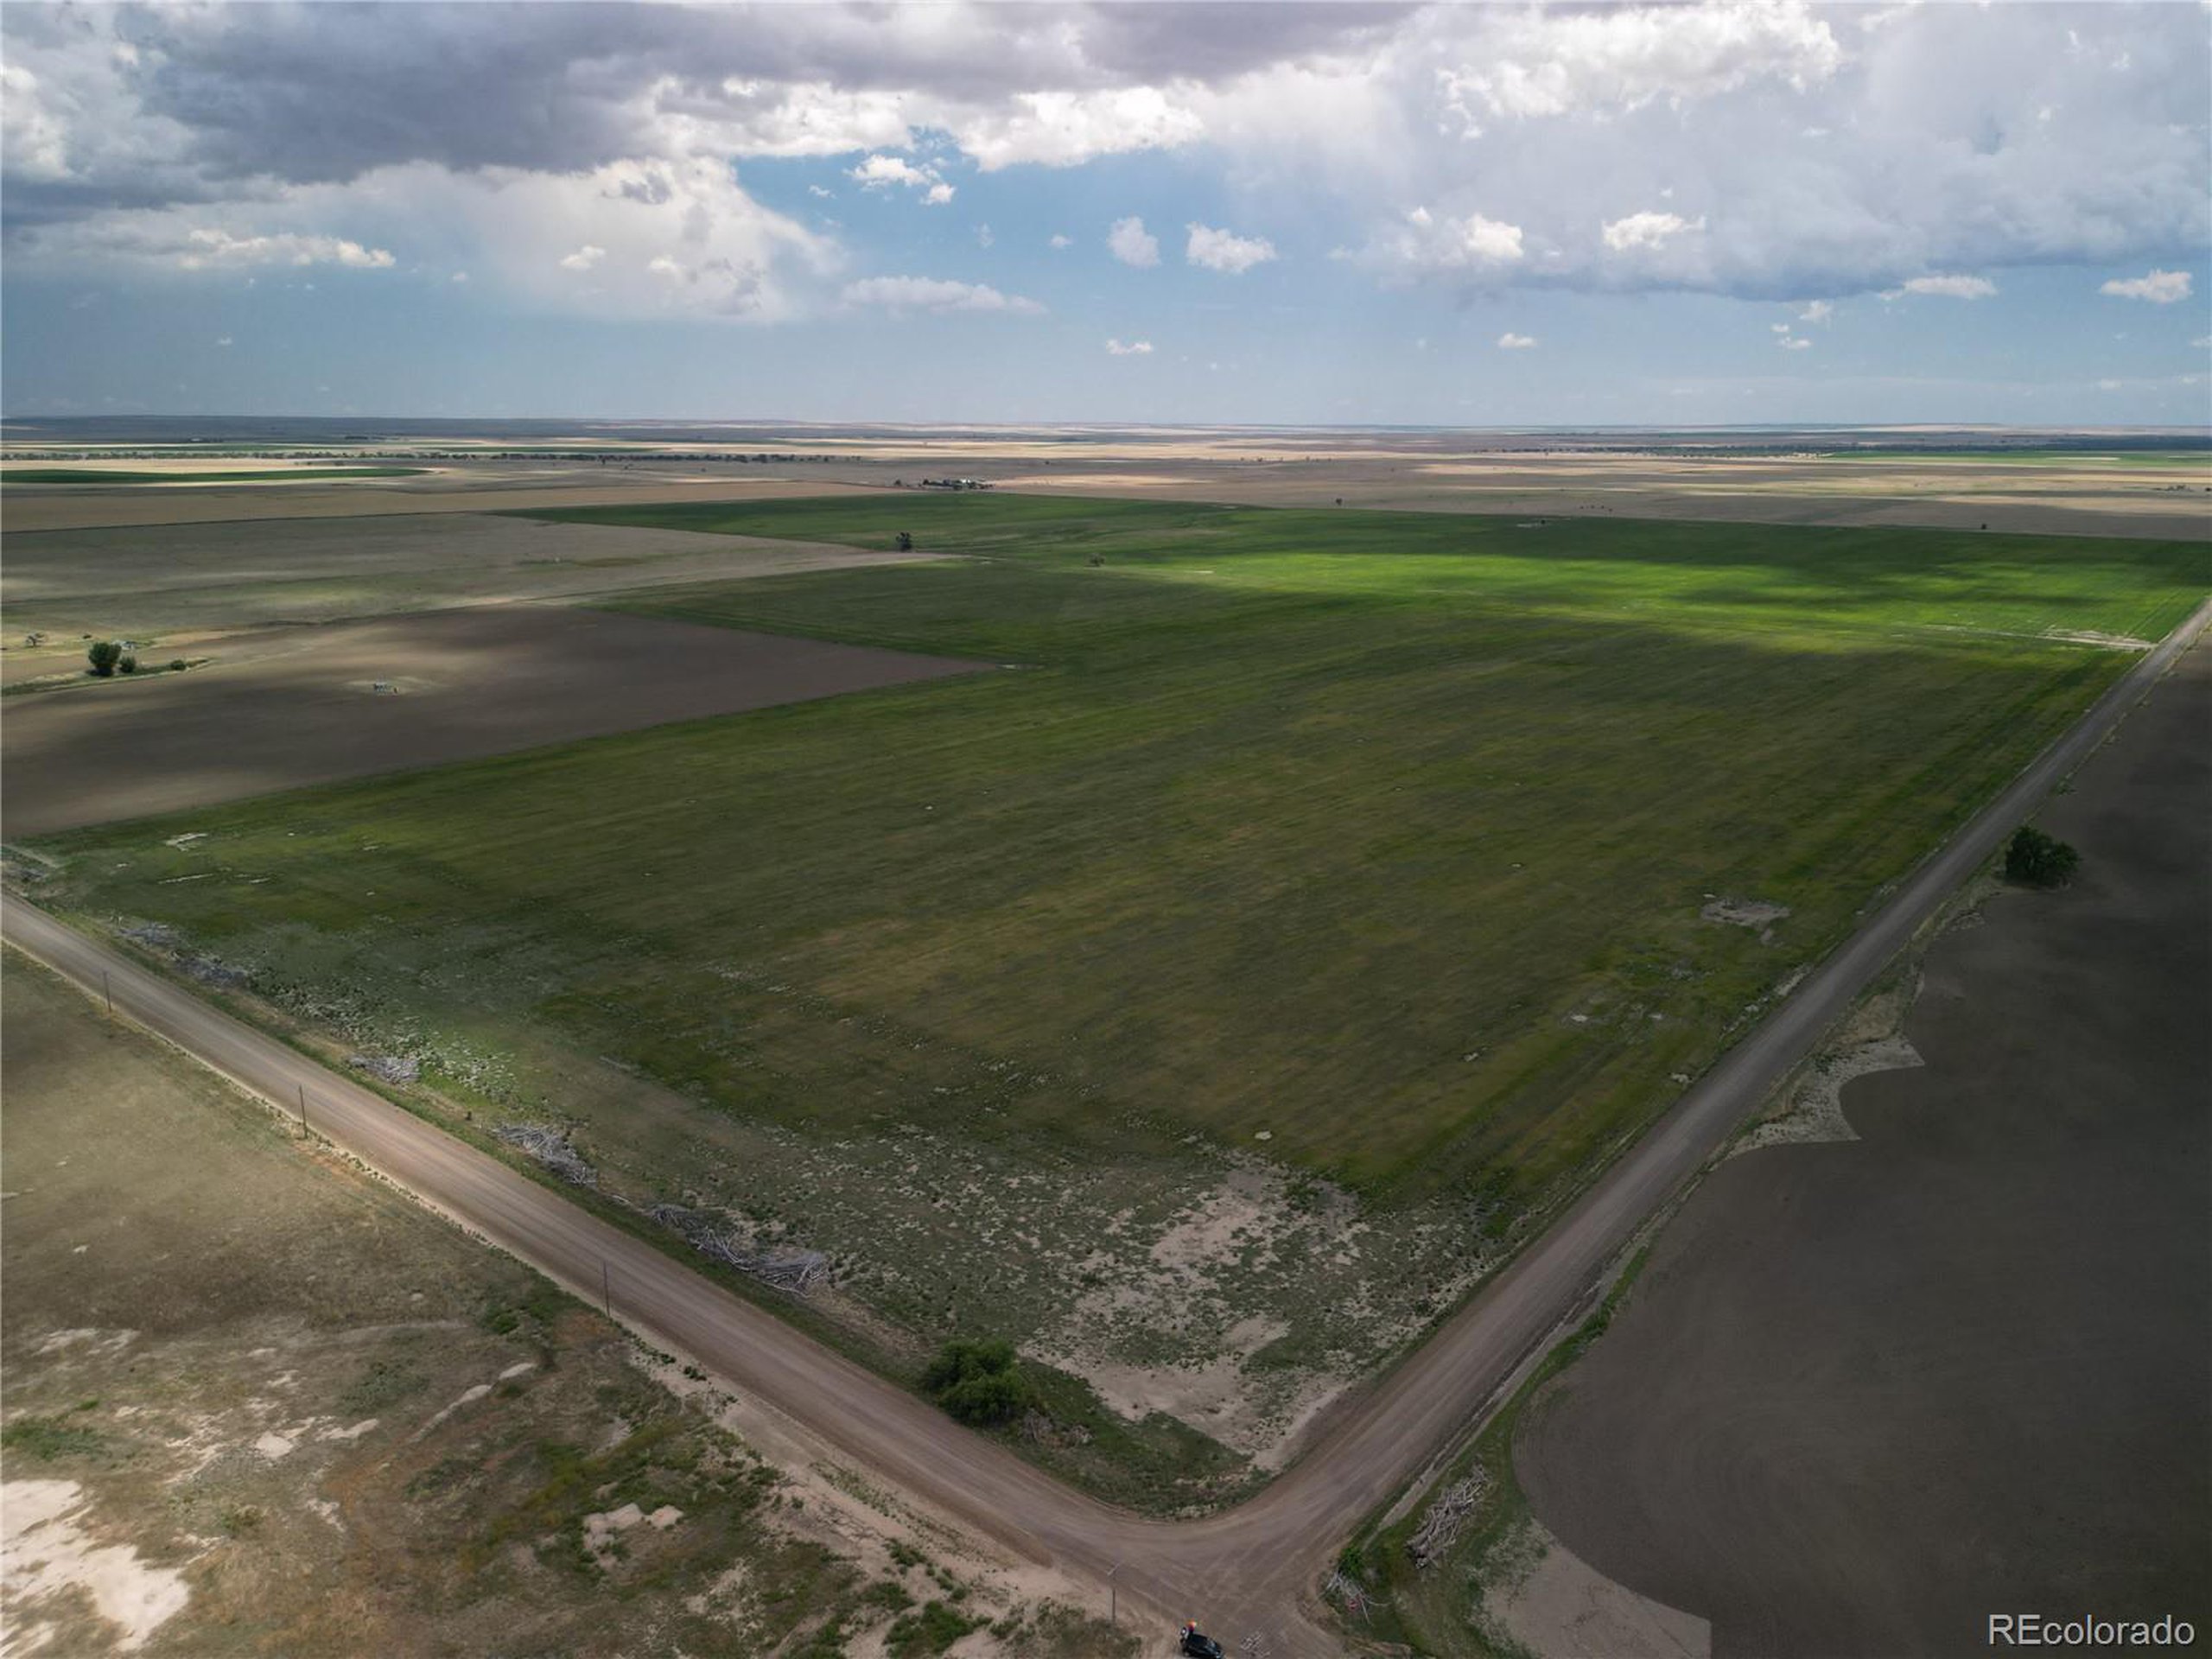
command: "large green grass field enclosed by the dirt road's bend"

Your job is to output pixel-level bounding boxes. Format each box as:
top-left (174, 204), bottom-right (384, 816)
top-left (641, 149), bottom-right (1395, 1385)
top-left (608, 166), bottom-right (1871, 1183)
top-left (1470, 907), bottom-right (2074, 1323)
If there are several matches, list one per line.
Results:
top-left (26, 495), bottom-right (2208, 1478)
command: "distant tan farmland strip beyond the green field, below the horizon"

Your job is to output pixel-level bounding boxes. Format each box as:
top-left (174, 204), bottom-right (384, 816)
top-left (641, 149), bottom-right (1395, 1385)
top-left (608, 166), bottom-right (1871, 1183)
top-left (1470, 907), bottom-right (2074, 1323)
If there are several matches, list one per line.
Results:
top-left (4, 431), bottom-right (2212, 537)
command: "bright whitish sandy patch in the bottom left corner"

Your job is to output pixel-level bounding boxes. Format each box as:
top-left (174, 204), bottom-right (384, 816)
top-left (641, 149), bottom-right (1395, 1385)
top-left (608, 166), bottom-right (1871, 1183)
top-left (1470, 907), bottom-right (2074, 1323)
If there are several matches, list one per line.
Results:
top-left (0, 1480), bottom-right (193, 1655)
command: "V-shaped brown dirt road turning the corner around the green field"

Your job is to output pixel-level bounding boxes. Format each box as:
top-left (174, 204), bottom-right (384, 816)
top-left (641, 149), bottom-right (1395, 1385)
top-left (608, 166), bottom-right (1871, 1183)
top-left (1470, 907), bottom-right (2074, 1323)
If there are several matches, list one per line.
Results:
top-left (0, 601), bottom-right (2212, 1659)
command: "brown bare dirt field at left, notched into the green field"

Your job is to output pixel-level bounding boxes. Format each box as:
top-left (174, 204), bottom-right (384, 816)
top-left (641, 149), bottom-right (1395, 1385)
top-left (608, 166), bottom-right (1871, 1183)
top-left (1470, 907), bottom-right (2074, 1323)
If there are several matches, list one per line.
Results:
top-left (0, 606), bottom-right (982, 836)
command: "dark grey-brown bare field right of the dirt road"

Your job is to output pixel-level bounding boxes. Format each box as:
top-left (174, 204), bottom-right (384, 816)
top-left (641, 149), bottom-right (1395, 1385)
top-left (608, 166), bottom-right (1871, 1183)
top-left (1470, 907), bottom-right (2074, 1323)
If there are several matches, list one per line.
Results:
top-left (1516, 644), bottom-right (2212, 1656)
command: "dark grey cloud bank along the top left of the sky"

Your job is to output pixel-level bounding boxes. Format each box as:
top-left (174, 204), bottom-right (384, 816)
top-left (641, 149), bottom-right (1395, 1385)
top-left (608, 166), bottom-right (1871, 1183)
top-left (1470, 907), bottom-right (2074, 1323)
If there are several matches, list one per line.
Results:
top-left (4, 3), bottom-right (1405, 206)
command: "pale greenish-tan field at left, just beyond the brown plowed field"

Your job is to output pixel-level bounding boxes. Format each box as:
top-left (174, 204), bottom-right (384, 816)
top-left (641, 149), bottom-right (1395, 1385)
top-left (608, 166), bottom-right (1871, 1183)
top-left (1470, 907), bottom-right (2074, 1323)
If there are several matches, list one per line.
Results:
top-left (0, 511), bottom-right (916, 686)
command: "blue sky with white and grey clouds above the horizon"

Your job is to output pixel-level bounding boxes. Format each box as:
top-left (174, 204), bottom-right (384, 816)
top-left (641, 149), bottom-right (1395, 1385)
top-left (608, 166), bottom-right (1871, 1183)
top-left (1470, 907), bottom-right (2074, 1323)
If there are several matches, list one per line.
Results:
top-left (0, 0), bottom-right (2212, 427)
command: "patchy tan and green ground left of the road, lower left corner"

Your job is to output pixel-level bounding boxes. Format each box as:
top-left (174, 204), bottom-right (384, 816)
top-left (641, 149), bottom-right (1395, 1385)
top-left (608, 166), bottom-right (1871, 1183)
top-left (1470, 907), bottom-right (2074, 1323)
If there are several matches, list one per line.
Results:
top-left (0, 953), bottom-right (1128, 1659)
